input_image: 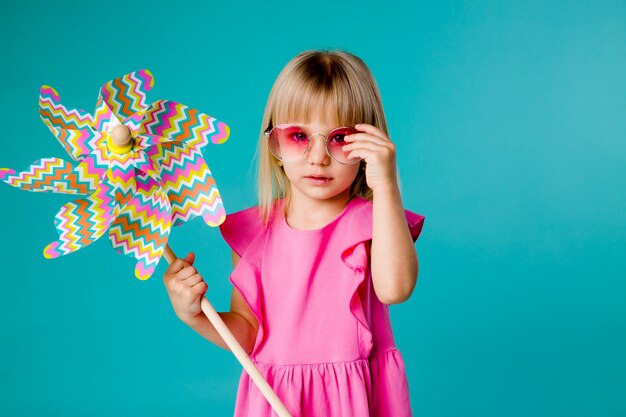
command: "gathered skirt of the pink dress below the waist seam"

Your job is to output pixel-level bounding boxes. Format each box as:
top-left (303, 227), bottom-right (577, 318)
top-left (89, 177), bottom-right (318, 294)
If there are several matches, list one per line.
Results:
top-left (235, 349), bottom-right (412, 417)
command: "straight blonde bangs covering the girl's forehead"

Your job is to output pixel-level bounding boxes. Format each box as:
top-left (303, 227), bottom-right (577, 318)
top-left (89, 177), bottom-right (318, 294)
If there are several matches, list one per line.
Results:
top-left (268, 56), bottom-right (375, 127)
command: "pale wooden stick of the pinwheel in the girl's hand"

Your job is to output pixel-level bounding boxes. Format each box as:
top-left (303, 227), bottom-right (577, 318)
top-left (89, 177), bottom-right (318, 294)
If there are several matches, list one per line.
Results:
top-left (158, 245), bottom-right (291, 417)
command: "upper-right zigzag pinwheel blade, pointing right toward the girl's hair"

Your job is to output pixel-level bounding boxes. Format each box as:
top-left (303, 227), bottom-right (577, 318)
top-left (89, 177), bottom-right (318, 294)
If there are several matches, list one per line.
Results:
top-left (139, 100), bottom-right (230, 151)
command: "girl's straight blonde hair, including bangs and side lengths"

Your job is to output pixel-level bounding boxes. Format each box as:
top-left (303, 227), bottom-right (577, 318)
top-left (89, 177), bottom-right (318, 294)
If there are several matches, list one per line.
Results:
top-left (257, 51), bottom-right (389, 224)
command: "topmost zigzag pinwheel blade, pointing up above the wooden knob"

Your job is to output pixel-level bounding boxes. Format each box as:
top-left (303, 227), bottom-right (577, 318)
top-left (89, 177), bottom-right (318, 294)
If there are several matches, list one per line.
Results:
top-left (100, 69), bottom-right (154, 121)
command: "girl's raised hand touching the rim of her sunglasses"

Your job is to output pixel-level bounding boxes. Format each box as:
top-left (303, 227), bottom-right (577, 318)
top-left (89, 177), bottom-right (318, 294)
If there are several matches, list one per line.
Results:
top-left (342, 123), bottom-right (398, 190)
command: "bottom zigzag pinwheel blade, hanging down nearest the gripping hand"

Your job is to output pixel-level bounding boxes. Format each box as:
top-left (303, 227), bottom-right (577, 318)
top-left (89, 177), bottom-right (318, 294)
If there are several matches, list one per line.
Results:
top-left (109, 173), bottom-right (171, 280)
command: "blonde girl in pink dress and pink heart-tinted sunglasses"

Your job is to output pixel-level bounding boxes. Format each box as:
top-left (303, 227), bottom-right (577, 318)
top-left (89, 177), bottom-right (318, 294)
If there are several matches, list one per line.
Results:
top-left (164, 51), bottom-right (424, 417)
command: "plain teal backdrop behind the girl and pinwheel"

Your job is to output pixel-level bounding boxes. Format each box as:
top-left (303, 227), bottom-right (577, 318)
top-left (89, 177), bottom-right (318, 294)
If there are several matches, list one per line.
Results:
top-left (0, 1), bottom-right (626, 417)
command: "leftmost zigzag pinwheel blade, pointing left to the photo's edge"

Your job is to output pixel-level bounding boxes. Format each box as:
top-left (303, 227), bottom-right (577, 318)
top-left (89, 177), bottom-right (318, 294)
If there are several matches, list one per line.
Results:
top-left (0, 158), bottom-right (95, 195)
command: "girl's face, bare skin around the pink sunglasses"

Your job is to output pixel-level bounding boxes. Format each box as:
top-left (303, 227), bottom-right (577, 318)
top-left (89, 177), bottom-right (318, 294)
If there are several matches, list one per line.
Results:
top-left (283, 112), bottom-right (360, 200)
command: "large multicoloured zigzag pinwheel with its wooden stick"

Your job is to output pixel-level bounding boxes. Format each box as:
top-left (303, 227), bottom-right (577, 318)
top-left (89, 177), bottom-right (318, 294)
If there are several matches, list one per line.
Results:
top-left (0, 70), bottom-right (289, 416)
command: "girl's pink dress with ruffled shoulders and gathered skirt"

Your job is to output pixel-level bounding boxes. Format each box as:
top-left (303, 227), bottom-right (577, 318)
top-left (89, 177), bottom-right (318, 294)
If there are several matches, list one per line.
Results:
top-left (220, 197), bottom-right (424, 417)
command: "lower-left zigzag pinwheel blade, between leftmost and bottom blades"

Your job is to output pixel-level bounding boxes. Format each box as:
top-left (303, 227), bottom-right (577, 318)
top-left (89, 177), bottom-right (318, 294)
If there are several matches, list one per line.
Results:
top-left (44, 168), bottom-right (135, 258)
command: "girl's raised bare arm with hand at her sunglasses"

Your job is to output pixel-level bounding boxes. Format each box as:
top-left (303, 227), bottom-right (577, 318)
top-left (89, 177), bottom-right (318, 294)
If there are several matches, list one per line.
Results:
top-left (344, 124), bottom-right (418, 304)
